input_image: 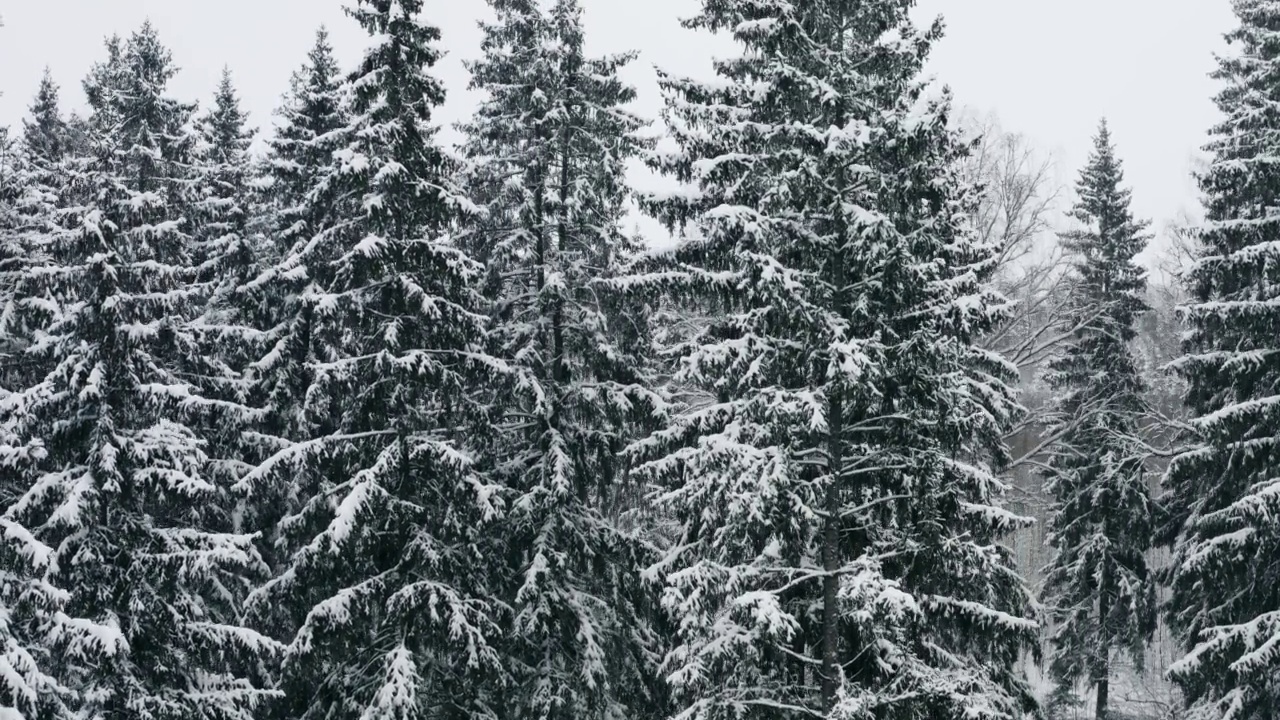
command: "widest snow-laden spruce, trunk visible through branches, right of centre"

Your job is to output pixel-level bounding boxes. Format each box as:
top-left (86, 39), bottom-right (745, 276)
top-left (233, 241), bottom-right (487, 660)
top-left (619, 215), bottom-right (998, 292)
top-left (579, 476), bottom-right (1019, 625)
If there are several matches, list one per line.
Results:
top-left (631, 0), bottom-right (1037, 720)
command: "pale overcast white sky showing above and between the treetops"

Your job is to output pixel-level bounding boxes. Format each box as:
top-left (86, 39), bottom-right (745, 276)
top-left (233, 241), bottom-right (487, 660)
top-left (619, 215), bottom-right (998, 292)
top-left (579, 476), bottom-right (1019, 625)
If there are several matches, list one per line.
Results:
top-left (0, 0), bottom-right (1233, 245)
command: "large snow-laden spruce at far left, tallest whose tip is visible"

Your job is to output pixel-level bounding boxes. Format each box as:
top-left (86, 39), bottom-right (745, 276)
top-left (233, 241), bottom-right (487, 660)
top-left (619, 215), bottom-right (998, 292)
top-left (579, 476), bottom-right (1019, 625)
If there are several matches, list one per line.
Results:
top-left (0, 26), bottom-right (273, 720)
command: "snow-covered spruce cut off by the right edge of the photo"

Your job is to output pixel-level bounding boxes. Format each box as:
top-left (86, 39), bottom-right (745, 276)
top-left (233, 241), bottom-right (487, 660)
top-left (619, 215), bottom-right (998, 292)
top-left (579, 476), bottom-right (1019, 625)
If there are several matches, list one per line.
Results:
top-left (1165, 0), bottom-right (1280, 720)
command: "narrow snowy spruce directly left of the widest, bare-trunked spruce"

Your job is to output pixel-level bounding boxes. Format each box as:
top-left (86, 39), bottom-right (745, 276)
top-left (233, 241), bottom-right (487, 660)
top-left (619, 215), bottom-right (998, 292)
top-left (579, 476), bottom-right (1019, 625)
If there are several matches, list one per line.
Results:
top-left (463, 0), bottom-right (664, 719)
